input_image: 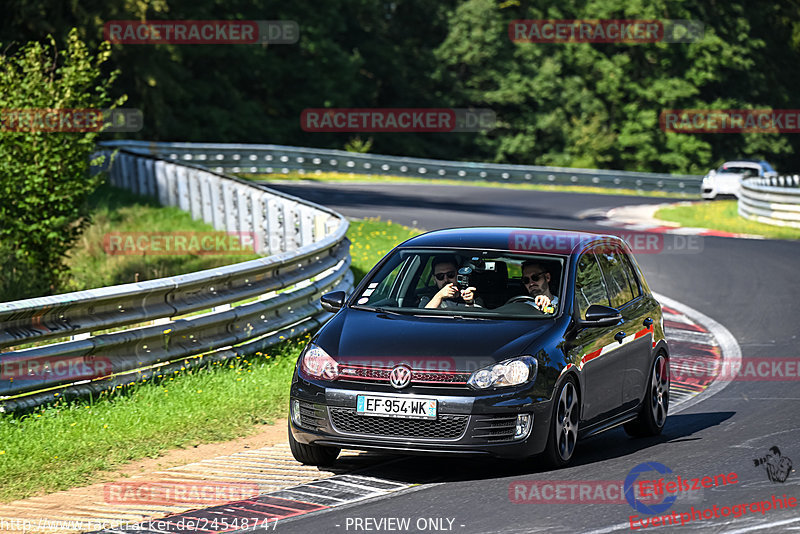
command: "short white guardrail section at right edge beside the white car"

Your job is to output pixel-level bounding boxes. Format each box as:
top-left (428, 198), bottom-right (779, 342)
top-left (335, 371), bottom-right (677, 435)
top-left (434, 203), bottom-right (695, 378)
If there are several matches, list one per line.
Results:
top-left (738, 174), bottom-right (800, 228)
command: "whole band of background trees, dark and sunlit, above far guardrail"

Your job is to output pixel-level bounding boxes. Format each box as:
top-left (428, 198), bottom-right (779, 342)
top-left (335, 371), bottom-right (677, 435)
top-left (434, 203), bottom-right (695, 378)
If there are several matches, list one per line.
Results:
top-left (0, 0), bottom-right (800, 182)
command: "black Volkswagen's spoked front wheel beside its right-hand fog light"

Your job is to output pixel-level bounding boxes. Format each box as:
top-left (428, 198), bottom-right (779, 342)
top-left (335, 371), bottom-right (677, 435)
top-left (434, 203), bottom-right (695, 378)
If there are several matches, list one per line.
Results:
top-left (544, 376), bottom-right (580, 468)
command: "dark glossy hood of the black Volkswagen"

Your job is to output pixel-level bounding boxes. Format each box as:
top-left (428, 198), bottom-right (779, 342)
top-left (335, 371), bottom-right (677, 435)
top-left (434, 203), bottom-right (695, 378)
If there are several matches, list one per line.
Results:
top-left (316, 308), bottom-right (557, 370)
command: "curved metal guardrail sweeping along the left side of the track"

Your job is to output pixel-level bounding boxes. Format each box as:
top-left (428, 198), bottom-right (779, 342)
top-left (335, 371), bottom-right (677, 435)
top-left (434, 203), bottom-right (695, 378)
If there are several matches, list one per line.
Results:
top-left (0, 150), bottom-right (353, 411)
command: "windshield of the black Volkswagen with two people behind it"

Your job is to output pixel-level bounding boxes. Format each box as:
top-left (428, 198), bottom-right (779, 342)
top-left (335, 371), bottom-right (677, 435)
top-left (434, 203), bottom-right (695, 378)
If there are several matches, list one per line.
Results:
top-left (354, 249), bottom-right (566, 318)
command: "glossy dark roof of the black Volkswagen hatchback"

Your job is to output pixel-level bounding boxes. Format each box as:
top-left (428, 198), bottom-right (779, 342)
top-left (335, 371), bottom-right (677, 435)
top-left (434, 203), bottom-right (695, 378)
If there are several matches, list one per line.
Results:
top-left (400, 226), bottom-right (624, 254)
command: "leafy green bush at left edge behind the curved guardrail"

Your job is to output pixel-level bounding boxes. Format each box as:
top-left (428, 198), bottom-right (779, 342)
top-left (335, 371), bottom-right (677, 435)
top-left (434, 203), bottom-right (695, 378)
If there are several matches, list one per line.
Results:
top-left (0, 30), bottom-right (122, 299)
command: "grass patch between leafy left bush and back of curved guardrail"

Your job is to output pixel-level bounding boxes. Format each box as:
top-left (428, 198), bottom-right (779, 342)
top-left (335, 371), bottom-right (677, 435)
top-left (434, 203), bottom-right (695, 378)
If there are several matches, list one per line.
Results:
top-left (62, 185), bottom-right (259, 292)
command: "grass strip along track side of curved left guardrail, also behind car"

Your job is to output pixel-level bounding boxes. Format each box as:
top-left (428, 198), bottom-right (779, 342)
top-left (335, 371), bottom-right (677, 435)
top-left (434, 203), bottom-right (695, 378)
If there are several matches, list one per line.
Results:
top-left (0, 219), bottom-right (419, 502)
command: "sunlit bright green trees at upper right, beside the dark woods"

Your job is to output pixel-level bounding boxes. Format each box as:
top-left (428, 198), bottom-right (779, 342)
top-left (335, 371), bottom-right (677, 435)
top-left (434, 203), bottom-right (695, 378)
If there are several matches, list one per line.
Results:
top-left (436, 0), bottom-right (800, 173)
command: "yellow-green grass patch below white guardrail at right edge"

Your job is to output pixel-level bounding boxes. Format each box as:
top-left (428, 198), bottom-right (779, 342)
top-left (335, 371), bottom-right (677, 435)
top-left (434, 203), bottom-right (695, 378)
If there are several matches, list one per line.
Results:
top-left (655, 200), bottom-right (800, 239)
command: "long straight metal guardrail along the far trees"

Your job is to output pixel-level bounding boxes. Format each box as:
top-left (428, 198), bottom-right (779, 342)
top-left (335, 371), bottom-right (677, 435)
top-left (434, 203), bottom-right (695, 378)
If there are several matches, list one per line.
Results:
top-left (98, 141), bottom-right (702, 194)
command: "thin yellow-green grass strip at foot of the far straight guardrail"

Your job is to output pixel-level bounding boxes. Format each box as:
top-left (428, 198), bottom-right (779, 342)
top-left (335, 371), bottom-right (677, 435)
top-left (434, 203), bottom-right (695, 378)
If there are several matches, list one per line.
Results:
top-left (240, 172), bottom-right (700, 198)
